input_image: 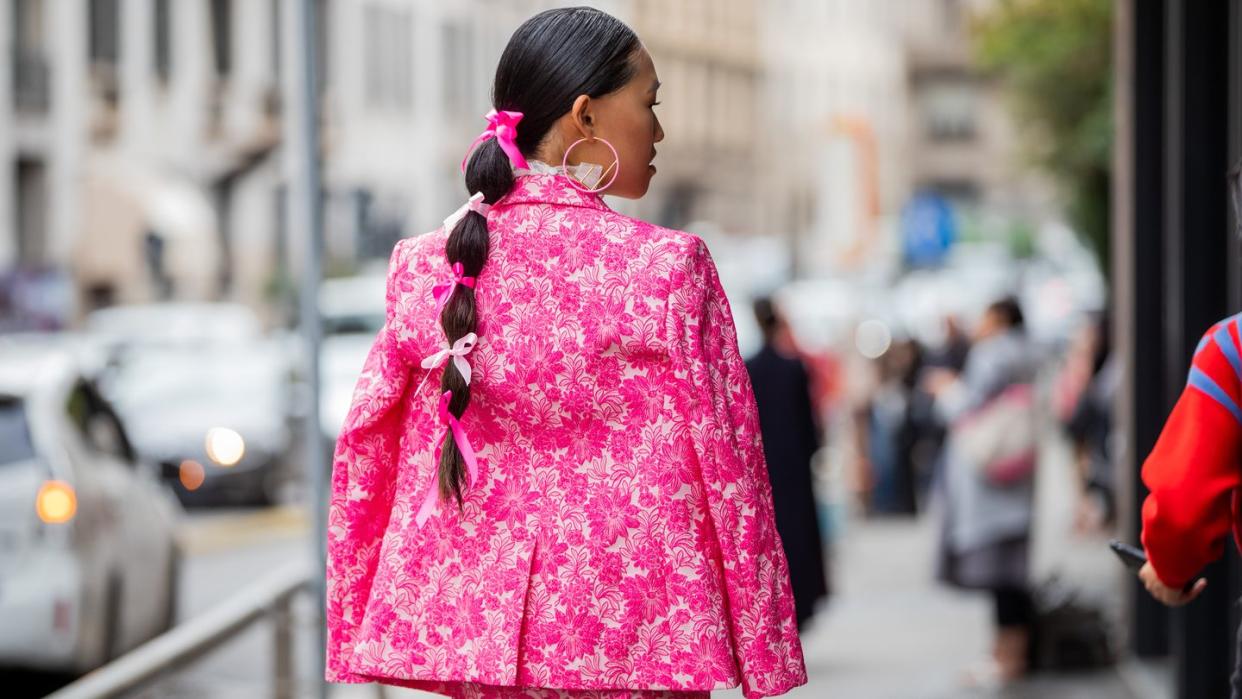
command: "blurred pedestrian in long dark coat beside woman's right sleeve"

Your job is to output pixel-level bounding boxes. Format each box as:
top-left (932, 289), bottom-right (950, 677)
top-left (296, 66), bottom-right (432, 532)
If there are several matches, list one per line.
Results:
top-left (746, 298), bottom-right (828, 628)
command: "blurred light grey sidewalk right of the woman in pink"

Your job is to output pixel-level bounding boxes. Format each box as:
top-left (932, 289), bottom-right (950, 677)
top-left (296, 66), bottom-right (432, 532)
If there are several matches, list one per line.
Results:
top-left (790, 518), bottom-right (1131, 699)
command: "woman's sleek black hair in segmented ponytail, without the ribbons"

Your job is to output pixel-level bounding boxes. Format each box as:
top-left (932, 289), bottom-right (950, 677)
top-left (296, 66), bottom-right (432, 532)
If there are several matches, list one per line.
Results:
top-left (440, 7), bottom-right (641, 507)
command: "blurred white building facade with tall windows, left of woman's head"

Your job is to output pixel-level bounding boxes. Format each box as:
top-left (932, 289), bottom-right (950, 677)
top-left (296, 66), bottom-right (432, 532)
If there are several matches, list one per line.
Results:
top-left (0, 0), bottom-right (625, 325)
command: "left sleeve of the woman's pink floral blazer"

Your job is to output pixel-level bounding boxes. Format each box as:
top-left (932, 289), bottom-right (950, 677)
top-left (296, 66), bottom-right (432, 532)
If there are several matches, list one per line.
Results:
top-left (324, 241), bottom-right (412, 683)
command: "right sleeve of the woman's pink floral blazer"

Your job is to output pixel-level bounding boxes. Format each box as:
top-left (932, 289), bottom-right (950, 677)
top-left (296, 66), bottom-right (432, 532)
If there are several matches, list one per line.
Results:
top-left (666, 238), bottom-right (806, 699)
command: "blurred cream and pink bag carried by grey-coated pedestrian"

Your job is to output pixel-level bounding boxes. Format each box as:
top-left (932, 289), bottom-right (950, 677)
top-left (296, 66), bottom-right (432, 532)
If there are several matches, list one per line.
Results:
top-left (953, 384), bottom-right (1037, 485)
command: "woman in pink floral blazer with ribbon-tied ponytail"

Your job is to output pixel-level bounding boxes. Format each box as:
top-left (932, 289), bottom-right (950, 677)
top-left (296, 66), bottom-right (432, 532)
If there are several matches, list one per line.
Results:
top-left (327, 7), bottom-right (806, 698)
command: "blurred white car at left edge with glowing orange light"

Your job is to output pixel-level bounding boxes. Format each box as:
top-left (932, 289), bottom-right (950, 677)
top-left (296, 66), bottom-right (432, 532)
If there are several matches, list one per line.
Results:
top-left (0, 338), bottom-right (181, 673)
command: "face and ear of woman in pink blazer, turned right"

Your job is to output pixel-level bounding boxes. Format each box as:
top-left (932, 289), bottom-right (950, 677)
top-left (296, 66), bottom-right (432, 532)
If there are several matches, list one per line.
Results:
top-left (566, 47), bottom-right (664, 199)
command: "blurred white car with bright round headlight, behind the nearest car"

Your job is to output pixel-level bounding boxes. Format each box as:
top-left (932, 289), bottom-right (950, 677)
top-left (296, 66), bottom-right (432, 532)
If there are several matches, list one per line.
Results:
top-left (87, 303), bottom-right (297, 505)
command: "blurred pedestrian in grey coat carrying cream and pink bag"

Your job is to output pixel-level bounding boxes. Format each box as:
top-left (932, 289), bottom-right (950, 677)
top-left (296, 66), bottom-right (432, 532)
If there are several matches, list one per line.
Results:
top-left (927, 299), bottom-right (1036, 685)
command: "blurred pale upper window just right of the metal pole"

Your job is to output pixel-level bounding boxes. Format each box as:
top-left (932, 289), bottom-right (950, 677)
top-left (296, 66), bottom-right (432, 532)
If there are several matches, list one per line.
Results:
top-left (363, 5), bottom-right (414, 109)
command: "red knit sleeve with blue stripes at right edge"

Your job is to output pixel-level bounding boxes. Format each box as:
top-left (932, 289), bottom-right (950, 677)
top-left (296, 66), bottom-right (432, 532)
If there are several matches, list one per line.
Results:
top-left (1143, 320), bottom-right (1242, 587)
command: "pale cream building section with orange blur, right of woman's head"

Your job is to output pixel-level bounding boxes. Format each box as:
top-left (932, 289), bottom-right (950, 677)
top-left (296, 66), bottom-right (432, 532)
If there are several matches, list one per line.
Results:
top-left (758, 0), bottom-right (907, 276)
